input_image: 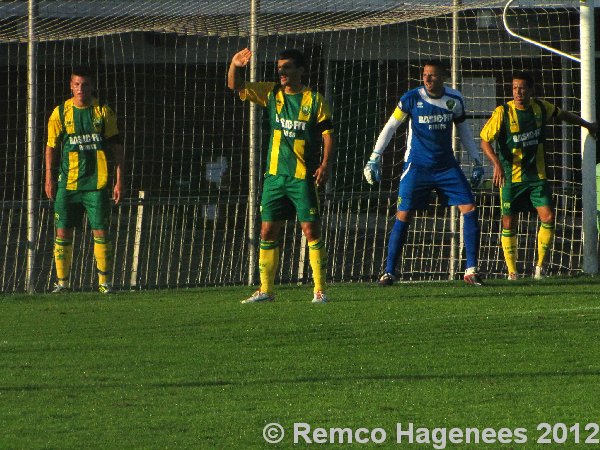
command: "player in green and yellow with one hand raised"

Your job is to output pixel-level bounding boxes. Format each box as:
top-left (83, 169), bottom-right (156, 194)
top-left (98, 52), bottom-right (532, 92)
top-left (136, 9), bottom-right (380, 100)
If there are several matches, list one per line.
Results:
top-left (227, 49), bottom-right (334, 303)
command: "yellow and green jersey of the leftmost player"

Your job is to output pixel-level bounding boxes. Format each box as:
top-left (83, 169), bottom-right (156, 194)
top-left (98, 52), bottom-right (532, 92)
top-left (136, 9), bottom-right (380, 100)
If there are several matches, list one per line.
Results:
top-left (47, 98), bottom-right (119, 191)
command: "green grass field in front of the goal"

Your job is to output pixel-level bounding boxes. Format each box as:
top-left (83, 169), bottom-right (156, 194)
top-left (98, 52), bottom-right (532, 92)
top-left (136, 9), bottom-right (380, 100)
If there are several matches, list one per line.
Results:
top-left (0, 278), bottom-right (600, 449)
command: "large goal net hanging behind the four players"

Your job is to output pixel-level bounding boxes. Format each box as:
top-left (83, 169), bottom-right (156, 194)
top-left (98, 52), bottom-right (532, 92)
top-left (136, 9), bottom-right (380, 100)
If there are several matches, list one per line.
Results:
top-left (0, 0), bottom-right (582, 292)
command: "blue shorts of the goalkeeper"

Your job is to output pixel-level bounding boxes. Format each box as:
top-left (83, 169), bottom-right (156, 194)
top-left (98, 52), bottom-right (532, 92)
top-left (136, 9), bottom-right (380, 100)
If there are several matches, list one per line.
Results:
top-left (398, 163), bottom-right (475, 211)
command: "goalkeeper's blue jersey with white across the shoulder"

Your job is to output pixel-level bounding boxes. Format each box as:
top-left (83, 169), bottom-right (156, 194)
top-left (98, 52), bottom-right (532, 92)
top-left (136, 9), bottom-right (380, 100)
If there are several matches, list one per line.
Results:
top-left (398, 86), bottom-right (466, 169)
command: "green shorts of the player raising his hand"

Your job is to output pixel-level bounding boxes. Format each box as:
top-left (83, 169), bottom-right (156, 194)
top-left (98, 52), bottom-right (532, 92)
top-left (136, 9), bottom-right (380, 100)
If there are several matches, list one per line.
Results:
top-left (260, 174), bottom-right (321, 222)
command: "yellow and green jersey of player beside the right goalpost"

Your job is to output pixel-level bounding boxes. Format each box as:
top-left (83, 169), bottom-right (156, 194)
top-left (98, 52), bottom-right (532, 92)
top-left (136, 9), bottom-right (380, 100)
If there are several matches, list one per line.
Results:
top-left (480, 99), bottom-right (560, 183)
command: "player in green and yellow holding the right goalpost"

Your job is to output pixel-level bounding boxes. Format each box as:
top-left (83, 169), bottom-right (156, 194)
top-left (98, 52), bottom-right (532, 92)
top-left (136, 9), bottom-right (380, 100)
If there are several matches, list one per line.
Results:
top-left (481, 72), bottom-right (598, 280)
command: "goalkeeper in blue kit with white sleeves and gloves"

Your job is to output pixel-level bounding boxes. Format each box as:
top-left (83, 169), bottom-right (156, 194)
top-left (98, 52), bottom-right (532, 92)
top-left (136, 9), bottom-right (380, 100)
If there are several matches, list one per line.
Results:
top-left (364, 61), bottom-right (483, 286)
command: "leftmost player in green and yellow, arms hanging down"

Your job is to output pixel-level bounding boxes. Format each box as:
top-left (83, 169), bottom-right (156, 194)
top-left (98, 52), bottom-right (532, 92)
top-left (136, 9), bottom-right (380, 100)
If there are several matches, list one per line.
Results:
top-left (45, 67), bottom-right (124, 294)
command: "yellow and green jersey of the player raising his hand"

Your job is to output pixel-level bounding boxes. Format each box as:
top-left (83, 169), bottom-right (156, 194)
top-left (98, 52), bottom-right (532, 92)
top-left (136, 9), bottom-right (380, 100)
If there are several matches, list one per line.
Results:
top-left (240, 82), bottom-right (333, 179)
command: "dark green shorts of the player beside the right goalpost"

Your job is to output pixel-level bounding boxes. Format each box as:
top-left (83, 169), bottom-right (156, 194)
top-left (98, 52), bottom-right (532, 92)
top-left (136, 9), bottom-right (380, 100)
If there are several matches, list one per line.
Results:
top-left (500, 180), bottom-right (552, 216)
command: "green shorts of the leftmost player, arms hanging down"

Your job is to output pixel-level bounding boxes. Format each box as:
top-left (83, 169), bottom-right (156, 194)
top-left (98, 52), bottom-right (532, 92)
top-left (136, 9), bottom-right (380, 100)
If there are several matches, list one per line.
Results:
top-left (54, 188), bottom-right (110, 231)
